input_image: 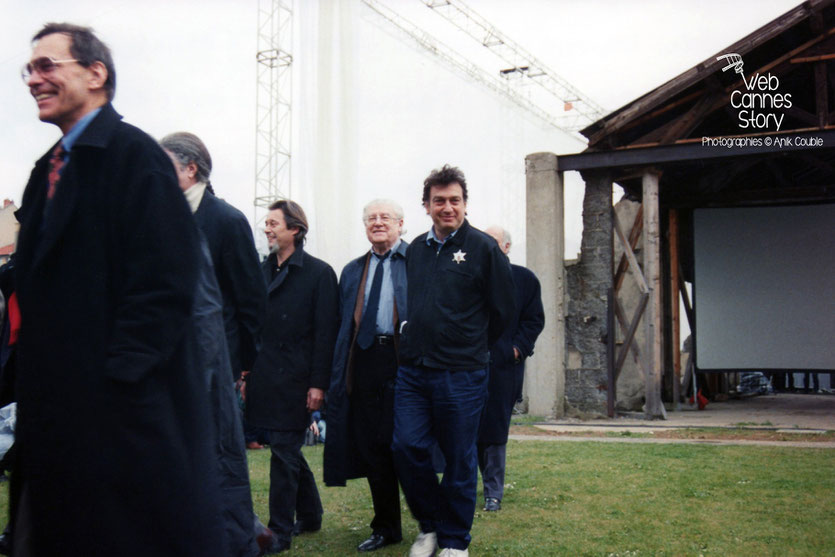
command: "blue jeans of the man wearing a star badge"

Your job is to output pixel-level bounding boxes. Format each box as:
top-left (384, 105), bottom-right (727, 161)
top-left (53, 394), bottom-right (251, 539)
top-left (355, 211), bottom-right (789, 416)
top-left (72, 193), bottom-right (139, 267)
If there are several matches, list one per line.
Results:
top-left (392, 366), bottom-right (487, 549)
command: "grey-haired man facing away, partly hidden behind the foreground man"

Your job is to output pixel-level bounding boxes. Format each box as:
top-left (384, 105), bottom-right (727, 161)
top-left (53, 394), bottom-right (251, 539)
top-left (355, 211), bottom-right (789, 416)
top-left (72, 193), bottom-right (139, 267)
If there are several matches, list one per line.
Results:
top-left (160, 132), bottom-right (269, 557)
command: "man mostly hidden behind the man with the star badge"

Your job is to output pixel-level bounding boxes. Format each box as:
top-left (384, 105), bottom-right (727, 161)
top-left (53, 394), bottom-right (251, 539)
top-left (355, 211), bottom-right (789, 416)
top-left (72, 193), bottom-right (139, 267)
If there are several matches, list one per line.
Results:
top-left (477, 226), bottom-right (545, 511)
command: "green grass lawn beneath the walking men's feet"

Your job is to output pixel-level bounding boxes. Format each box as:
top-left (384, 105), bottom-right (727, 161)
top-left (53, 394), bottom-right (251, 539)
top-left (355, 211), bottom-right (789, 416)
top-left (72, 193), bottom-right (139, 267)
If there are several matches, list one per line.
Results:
top-left (0, 441), bottom-right (835, 557)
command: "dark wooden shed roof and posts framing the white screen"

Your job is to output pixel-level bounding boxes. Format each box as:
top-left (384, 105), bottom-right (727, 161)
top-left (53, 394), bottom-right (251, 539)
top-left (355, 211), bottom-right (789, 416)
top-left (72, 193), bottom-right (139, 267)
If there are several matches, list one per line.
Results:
top-left (528, 0), bottom-right (835, 417)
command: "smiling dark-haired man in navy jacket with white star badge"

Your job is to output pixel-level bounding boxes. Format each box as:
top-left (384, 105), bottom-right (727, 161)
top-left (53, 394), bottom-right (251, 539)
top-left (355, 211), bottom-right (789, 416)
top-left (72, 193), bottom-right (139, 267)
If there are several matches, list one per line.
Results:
top-left (392, 165), bottom-right (515, 557)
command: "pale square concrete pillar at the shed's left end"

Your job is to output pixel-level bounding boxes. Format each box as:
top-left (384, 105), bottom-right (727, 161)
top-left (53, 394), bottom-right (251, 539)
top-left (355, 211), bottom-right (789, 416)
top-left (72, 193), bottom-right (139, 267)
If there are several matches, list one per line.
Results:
top-left (525, 153), bottom-right (565, 417)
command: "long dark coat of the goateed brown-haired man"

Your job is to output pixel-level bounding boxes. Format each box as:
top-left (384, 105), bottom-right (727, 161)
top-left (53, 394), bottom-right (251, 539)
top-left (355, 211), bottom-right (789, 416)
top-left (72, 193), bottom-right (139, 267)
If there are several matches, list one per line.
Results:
top-left (246, 247), bottom-right (339, 431)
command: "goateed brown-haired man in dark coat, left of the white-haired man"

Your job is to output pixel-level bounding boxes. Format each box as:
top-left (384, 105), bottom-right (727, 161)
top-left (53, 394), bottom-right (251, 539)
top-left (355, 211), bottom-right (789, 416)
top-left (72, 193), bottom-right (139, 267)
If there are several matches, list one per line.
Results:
top-left (246, 200), bottom-right (339, 552)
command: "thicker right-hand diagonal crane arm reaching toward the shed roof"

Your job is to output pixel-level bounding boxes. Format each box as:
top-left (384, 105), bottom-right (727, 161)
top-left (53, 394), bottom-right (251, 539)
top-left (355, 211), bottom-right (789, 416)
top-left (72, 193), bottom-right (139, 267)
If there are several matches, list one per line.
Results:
top-left (420, 0), bottom-right (605, 132)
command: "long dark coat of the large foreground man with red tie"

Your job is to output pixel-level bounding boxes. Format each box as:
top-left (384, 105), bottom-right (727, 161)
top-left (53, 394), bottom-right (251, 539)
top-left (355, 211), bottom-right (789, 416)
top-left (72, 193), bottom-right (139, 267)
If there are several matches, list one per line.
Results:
top-left (13, 104), bottom-right (229, 557)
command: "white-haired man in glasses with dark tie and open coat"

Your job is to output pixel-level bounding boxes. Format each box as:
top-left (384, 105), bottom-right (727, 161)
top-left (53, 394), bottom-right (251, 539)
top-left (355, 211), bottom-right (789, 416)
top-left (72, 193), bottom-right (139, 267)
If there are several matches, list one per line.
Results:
top-left (324, 199), bottom-right (408, 552)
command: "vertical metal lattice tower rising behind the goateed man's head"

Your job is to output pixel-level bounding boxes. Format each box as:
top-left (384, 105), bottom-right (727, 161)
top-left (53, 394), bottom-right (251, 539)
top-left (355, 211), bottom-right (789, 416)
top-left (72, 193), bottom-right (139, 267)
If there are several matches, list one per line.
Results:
top-left (255, 0), bottom-right (293, 225)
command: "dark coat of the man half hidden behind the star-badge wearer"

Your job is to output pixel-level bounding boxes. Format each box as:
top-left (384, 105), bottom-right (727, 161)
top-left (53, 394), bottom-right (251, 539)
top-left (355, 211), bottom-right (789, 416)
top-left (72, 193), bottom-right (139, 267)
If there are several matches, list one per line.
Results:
top-left (478, 265), bottom-right (545, 445)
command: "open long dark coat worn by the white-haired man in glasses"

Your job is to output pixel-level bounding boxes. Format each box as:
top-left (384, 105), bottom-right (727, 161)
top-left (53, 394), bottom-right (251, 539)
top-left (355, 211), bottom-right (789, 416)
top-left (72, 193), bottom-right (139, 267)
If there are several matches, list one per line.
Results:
top-left (324, 241), bottom-right (409, 486)
